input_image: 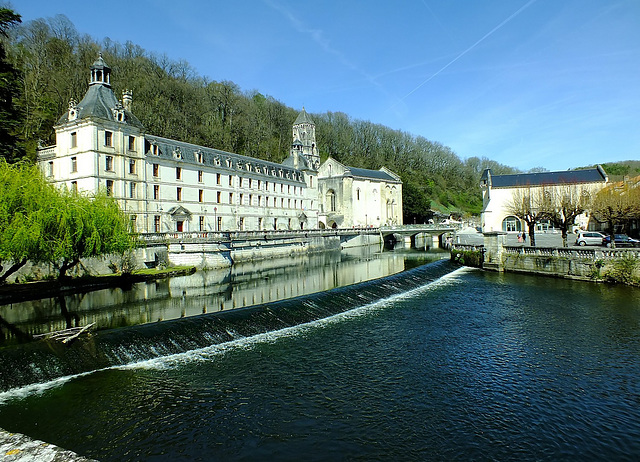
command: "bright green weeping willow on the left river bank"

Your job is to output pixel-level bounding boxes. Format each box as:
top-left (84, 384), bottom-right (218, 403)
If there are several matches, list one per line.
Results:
top-left (0, 159), bottom-right (134, 284)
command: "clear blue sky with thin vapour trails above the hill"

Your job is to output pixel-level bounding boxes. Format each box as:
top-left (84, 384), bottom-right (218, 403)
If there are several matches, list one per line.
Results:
top-left (13, 0), bottom-right (640, 170)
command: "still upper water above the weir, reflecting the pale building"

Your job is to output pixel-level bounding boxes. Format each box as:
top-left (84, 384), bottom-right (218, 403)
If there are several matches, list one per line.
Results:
top-left (0, 248), bottom-right (430, 338)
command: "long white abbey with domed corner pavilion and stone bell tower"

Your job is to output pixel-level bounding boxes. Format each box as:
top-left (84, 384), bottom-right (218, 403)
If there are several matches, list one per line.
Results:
top-left (38, 57), bottom-right (402, 233)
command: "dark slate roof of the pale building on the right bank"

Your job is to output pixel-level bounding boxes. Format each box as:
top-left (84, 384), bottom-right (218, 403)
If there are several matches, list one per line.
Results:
top-left (483, 166), bottom-right (608, 188)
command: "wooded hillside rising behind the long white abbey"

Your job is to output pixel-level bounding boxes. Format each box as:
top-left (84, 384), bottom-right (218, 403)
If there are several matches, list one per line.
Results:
top-left (6, 15), bottom-right (515, 223)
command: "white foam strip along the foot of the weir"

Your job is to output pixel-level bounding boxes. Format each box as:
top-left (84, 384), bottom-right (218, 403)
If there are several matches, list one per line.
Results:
top-left (0, 267), bottom-right (474, 405)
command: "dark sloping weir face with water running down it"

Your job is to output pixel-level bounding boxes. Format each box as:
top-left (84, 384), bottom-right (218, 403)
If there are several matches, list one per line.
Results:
top-left (0, 260), bottom-right (457, 392)
